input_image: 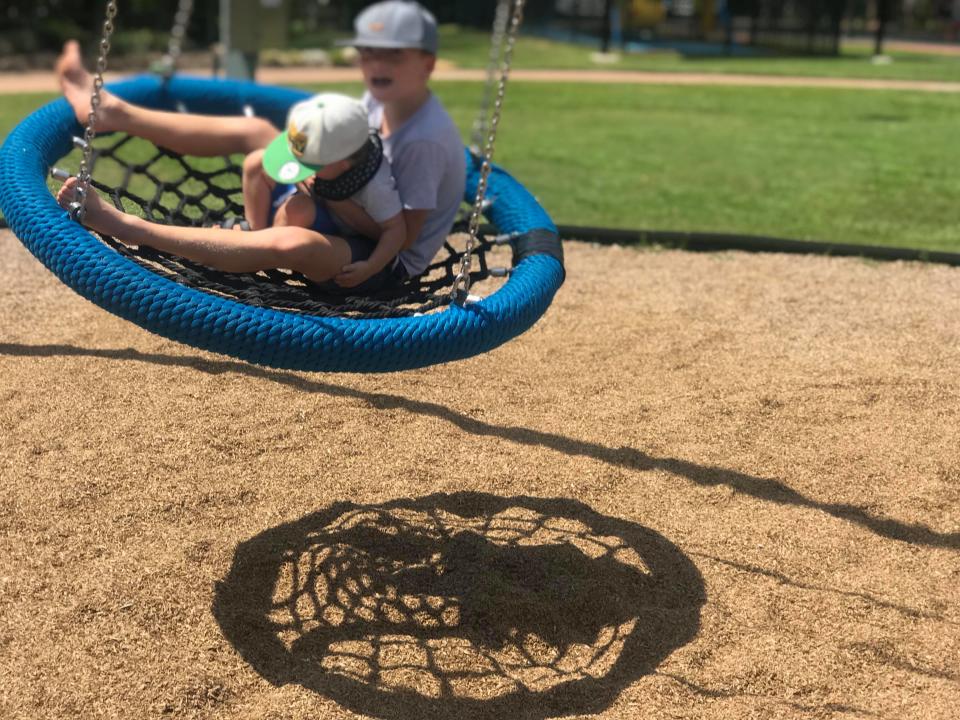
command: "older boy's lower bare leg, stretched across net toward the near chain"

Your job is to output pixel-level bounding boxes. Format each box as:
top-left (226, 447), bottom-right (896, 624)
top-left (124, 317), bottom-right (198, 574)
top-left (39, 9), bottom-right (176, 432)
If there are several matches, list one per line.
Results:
top-left (57, 178), bottom-right (351, 282)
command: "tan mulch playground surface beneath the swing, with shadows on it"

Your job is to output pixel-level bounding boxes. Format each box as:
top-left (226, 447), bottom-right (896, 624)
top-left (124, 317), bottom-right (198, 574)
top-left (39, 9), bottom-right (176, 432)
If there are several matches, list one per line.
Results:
top-left (0, 231), bottom-right (960, 720)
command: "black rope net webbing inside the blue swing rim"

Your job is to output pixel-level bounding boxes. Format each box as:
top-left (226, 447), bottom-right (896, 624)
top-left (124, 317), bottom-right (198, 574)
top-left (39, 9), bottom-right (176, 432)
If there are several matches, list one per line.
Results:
top-left (79, 133), bottom-right (493, 318)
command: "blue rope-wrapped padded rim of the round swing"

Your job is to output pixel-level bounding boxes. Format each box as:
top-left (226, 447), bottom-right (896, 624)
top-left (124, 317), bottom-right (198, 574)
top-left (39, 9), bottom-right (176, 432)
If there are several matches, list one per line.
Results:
top-left (0, 76), bottom-right (564, 372)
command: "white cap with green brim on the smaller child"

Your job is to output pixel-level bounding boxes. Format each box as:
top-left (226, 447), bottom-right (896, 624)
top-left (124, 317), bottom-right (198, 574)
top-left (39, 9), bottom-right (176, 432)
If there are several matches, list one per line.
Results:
top-left (263, 93), bottom-right (370, 183)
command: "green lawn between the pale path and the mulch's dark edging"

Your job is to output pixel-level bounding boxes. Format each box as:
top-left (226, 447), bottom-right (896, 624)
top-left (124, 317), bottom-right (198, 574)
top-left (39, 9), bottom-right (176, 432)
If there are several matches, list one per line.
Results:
top-left (0, 82), bottom-right (960, 251)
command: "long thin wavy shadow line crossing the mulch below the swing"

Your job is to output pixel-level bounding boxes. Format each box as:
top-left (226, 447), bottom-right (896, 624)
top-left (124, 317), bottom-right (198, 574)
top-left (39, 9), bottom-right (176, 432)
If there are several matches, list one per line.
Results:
top-left (0, 343), bottom-right (960, 550)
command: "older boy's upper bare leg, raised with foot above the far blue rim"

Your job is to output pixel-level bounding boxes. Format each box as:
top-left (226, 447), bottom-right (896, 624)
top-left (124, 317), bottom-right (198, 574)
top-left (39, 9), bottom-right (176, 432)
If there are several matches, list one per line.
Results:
top-left (56, 40), bottom-right (279, 157)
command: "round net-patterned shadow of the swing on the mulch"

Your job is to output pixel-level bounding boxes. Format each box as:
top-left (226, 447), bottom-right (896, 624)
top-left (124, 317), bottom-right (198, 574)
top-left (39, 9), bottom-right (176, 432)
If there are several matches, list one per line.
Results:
top-left (213, 492), bottom-right (706, 720)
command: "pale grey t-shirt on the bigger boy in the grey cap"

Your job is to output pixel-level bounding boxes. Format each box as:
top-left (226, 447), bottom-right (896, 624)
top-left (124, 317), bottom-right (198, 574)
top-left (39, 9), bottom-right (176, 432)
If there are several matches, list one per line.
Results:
top-left (363, 93), bottom-right (466, 275)
